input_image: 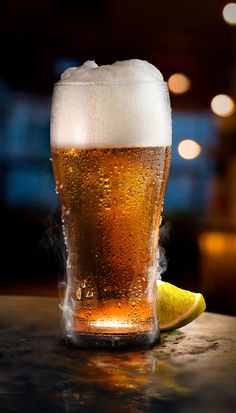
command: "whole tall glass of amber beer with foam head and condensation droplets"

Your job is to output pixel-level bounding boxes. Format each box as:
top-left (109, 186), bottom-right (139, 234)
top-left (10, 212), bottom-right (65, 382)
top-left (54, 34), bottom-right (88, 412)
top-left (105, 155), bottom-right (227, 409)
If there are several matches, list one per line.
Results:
top-left (51, 60), bottom-right (171, 348)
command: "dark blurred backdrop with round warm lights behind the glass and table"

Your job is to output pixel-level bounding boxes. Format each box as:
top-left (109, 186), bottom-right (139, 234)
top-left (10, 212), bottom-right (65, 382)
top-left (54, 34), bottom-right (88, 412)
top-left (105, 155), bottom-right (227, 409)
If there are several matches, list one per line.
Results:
top-left (0, 0), bottom-right (236, 315)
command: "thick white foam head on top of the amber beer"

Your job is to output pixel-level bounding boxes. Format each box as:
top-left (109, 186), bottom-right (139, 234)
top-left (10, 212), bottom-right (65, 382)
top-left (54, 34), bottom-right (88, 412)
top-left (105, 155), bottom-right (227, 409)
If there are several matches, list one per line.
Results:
top-left (51, 59), bottom-right (171, 148)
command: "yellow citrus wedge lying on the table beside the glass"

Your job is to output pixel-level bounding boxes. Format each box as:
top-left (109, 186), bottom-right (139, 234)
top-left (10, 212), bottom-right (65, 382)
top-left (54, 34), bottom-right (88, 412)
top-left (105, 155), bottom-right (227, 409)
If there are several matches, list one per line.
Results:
top-left (157, 280), bottom-right (206, 331)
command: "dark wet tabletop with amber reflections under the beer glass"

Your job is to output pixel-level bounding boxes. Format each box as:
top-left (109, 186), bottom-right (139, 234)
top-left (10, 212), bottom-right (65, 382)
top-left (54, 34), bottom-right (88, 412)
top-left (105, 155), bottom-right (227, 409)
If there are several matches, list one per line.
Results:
top-left (0, 296), bottom-right (236, 413)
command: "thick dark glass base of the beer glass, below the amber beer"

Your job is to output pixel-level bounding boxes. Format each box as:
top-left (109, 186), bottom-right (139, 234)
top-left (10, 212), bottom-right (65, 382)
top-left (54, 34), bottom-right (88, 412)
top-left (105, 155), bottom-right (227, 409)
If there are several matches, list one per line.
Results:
top-left (65, 329), bottom-right (160, 350)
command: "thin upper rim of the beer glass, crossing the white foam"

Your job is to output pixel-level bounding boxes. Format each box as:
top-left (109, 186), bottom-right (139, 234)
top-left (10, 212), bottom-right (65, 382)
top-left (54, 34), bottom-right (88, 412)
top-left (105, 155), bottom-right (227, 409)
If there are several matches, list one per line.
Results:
top-left (54, 80), bottom-right (168, 87)
